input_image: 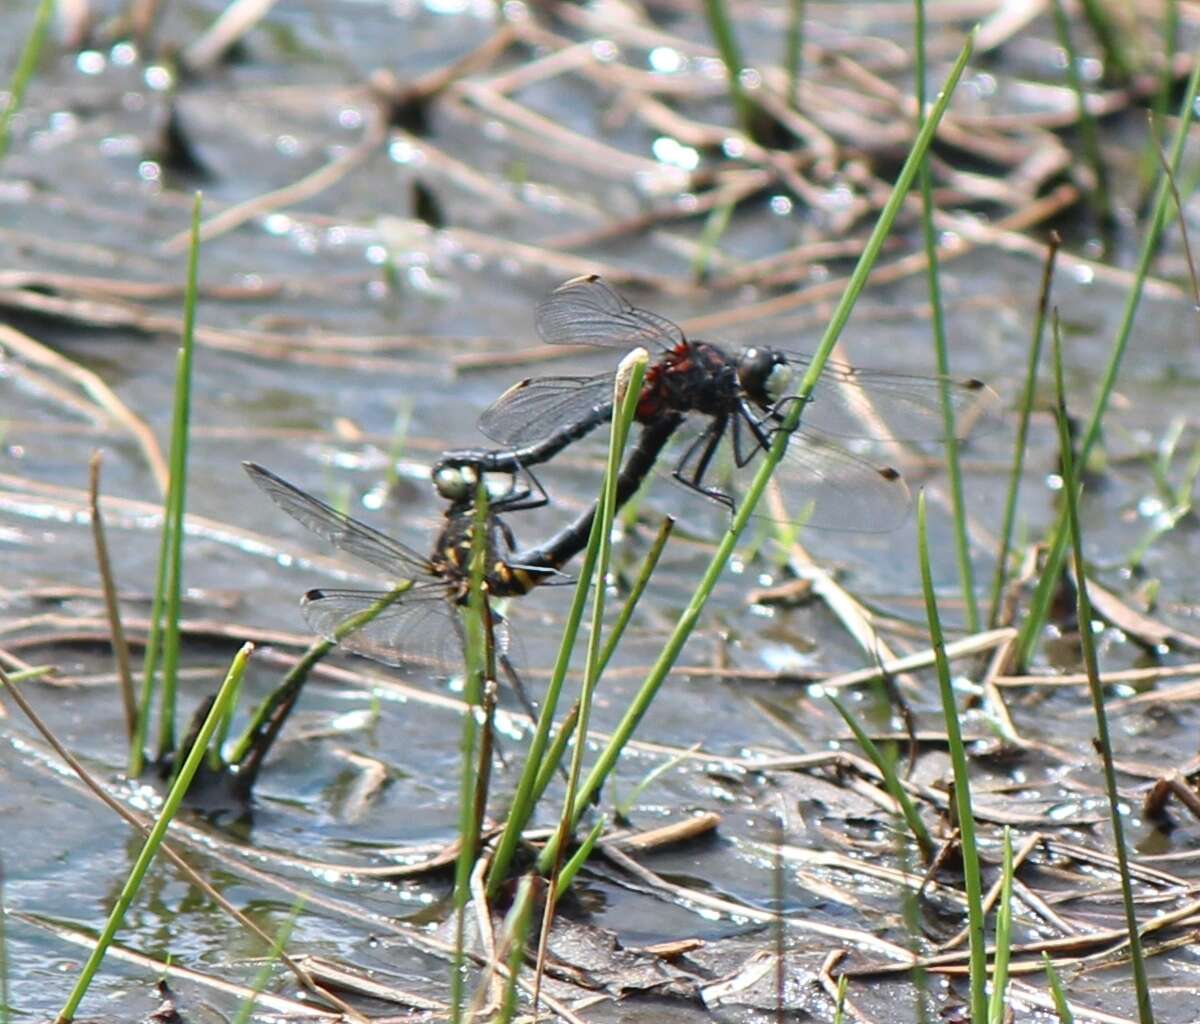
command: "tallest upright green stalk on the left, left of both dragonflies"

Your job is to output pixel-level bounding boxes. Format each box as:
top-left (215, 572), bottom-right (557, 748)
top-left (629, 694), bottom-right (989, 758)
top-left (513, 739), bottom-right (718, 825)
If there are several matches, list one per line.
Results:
top-left (158, 192), bottom-right (200, 762)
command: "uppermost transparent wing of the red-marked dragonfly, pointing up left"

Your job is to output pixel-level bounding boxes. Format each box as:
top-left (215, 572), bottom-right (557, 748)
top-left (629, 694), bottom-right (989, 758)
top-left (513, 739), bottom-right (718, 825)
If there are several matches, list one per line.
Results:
top-left (538, 275), bottom-right (684, 351)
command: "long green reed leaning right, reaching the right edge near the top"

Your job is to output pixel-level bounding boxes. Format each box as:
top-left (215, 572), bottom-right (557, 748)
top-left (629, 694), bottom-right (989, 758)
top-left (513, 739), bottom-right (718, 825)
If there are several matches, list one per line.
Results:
top-left (1016, 59), bottom-right (1200, 667)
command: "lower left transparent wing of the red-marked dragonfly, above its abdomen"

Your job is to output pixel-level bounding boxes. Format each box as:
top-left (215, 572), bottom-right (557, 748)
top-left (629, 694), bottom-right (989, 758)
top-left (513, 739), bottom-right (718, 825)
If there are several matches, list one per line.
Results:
top-left (479, 373), bottom-right (612, 447)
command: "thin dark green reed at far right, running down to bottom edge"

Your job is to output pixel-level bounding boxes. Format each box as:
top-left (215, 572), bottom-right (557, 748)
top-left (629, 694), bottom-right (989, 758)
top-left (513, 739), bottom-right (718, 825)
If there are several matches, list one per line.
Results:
top-left (1054, 317), bottom-right (1154, 1024)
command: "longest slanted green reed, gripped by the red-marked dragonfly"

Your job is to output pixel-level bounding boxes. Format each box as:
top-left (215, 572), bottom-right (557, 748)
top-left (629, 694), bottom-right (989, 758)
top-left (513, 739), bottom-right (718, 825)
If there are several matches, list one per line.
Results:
top-left (544, 32), bottom-right (974, 856)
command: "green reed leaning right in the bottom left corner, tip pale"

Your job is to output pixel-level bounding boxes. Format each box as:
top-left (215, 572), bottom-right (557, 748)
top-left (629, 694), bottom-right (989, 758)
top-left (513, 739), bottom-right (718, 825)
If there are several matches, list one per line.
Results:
top-left (55, 643), bottom-right (254, 1024)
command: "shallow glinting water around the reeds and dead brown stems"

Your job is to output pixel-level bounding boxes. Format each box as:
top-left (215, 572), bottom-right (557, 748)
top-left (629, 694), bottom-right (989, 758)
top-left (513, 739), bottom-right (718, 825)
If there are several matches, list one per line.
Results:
top-left (0, 4), bottom-right (1200, 1022)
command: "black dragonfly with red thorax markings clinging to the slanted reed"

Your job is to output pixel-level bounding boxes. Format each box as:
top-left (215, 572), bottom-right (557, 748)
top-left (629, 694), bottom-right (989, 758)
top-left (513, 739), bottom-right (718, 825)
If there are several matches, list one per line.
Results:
top-left (463, 275), bottom-right (998, 532)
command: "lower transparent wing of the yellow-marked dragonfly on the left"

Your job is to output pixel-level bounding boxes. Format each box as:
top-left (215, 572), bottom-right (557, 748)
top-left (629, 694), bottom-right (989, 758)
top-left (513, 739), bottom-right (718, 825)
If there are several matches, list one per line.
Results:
top-left (300, 586), bottom-right (462, 672)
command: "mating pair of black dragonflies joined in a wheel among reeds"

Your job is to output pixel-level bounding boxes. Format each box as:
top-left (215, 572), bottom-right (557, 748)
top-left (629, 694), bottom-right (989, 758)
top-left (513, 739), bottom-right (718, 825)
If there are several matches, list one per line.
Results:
top-left (246, 276), bottom-right (997, 664)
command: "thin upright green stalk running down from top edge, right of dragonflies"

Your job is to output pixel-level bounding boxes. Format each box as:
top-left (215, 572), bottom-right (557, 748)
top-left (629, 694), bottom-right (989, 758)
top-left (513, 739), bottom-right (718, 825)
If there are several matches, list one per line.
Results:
top-left (914, 0), bottom-right (979, 633)
